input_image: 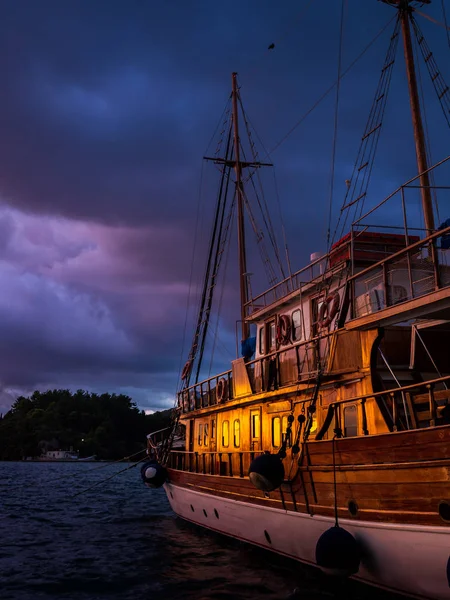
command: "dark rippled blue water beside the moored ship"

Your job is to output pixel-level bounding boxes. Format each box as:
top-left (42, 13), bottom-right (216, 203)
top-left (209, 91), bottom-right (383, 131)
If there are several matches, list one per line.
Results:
top-left (0, 462), bottom-right (400, 600)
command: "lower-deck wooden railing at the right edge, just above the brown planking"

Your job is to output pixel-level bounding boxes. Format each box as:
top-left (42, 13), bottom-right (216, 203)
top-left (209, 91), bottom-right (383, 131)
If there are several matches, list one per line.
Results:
top-left (315, 375), bottom-right (450, 440)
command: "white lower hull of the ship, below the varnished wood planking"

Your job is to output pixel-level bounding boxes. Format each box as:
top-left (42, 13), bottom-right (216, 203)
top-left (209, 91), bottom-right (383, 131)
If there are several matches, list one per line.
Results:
top-left (165, 483), bottom-right (450, 600)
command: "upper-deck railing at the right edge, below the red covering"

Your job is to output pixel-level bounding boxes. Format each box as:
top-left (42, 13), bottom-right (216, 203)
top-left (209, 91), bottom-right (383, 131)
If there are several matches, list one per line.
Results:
top-left (349, 227), bottom-right (450, 318)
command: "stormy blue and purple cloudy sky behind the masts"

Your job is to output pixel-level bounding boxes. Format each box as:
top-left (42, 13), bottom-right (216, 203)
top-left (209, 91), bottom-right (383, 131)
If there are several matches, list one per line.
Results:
top-left (0, 0), bottom-right (450, 411)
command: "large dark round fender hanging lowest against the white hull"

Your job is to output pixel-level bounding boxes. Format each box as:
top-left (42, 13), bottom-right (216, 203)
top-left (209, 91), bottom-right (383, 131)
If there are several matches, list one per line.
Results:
top-left (316, 525), bottom-right (361, 577)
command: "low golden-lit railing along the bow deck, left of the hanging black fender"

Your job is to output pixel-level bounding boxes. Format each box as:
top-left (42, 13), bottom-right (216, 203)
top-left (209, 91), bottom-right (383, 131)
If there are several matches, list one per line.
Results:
top-left (167, 449), bottom-right (264, 477)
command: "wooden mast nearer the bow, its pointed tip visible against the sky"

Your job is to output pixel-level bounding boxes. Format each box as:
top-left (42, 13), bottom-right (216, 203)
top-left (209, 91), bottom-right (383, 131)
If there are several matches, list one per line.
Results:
top-left (232, 73), bottom-right (250, 340)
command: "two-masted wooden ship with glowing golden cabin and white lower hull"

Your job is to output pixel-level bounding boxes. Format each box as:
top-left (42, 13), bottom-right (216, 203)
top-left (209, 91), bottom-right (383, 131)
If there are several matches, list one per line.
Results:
top-left (141, 0), bottom-right (450, 600)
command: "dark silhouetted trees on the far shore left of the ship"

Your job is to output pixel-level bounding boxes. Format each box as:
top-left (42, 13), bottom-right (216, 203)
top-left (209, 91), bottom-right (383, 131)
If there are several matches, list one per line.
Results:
top-left (0, 390), bottom-right (172, 460)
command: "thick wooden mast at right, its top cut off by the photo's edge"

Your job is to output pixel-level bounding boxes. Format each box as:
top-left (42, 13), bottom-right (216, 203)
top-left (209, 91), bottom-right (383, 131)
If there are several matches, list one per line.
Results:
top-left (398, 0), bottom-right (435, 235)
